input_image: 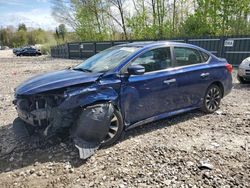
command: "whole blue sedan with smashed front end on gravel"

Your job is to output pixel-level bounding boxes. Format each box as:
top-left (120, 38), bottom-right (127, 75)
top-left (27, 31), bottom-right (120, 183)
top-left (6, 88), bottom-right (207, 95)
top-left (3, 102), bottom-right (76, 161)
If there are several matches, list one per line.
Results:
top-left (13, 41), bottom-right (232, 159)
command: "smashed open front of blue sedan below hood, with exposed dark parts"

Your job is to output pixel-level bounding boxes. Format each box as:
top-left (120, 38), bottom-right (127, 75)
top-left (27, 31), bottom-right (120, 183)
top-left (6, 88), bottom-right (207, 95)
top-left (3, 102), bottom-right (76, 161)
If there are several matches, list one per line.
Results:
top-left (13, 97), bottom-right (74, 132)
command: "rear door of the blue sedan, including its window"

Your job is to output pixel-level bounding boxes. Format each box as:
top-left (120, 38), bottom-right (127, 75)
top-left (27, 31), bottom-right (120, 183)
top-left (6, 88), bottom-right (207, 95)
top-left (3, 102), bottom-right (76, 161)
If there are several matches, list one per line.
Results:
top-left (173, 46), bottom-right (214, 109)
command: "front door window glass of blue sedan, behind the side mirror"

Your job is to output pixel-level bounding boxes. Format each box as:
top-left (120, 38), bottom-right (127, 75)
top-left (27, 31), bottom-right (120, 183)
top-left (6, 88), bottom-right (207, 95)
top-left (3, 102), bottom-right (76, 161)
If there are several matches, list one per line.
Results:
top-left (131, 47), bottom-right (172, 72)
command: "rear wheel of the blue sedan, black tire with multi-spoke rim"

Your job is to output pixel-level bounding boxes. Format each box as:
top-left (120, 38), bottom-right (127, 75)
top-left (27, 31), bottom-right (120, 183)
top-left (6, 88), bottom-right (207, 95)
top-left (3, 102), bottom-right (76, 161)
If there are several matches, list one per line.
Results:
top-left (201, 84), bottom-right (222, 114)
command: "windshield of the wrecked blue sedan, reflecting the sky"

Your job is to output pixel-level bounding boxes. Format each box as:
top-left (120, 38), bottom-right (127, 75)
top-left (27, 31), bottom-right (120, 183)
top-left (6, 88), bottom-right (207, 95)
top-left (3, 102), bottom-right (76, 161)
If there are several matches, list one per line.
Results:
top-left (73, 46), bottom-right (139, 72)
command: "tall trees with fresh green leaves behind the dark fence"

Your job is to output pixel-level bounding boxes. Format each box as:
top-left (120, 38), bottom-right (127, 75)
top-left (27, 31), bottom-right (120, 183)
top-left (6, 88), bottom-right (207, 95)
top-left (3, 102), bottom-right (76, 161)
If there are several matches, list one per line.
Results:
top-left (52, 0), bottom-right (250, 40)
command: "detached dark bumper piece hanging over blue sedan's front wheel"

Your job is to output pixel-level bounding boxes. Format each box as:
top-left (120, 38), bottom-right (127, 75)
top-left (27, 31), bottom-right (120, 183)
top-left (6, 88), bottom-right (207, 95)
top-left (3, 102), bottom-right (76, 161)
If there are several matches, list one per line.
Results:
top-left (71, 103), bottom-right (114, 159)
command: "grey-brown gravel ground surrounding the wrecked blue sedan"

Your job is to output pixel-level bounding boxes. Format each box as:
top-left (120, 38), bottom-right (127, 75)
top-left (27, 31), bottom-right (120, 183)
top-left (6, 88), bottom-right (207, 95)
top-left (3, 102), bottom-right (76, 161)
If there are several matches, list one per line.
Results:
top-left (0, 53), bottom-right (250, 188)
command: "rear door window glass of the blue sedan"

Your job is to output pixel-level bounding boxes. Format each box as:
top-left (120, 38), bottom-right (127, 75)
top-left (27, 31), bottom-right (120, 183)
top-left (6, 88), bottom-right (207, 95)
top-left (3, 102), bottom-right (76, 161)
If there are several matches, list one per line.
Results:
top-left (174, 47), bottom-right (203, 67)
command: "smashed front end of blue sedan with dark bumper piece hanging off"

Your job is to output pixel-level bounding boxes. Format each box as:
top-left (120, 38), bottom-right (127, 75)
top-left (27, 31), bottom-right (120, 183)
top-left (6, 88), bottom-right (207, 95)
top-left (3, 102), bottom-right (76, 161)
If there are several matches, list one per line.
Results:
top-left (14, 94), bottom-right (114, 159)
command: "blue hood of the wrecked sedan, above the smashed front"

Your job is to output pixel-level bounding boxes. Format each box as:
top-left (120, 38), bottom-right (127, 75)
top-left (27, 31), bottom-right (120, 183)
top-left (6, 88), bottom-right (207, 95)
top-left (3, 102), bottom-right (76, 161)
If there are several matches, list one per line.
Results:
top-left (15, 69), bottom-right (102, 95)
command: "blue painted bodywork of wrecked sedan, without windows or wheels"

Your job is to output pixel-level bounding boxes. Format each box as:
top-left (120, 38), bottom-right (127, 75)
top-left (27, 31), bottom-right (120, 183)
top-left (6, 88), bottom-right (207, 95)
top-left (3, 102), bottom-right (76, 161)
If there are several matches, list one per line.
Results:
top-left (15, 42), bottom-right (232, 127)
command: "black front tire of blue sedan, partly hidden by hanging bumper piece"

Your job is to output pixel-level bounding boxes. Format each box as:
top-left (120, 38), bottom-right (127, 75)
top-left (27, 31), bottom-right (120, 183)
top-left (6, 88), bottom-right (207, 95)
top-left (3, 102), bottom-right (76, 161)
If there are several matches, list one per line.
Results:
top-left (101, 108), bottom-right (124, 147)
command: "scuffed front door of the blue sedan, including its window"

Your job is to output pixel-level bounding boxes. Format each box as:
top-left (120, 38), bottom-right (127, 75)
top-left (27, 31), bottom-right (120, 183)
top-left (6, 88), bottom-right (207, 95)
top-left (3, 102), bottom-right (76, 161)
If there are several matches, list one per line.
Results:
top-left (121, 47), bottom-right (178, 124)
